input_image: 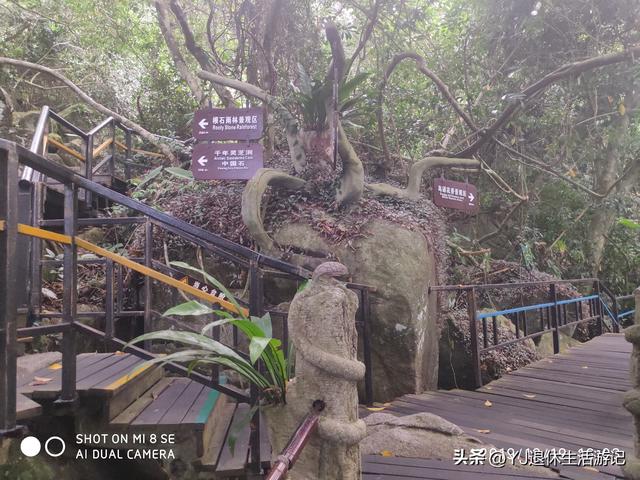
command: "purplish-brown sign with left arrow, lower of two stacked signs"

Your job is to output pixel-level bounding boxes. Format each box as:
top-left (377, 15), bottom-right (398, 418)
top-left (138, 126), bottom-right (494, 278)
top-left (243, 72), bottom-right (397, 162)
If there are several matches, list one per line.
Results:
top-left (191, 143), bottom-right (263, 180)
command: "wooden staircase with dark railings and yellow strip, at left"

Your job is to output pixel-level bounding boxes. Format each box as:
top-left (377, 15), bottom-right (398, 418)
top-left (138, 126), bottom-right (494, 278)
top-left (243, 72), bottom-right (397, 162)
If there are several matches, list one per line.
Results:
top-left (0, 108), bottom-right (378, 478)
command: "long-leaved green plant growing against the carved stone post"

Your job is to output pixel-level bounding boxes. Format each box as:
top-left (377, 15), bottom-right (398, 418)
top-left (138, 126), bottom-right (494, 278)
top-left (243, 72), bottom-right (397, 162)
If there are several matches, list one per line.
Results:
top-left (130, 262), bottom-right (291, 404)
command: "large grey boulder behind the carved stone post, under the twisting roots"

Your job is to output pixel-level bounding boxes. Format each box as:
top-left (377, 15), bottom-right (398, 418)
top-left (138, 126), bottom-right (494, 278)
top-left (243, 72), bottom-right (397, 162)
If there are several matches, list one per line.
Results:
top-left (273, 219), bottom-right (439, 401)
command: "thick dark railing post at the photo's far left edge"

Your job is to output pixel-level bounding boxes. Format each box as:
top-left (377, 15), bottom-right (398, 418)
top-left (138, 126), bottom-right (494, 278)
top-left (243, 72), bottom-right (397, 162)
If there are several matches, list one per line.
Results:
top-left (0, 146), bottom-right (18, 437)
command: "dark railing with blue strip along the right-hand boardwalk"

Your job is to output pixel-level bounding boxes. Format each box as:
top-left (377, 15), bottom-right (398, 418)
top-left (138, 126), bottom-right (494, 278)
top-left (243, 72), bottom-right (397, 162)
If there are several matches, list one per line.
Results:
top-left (430, 278), bottom-right (633, 388)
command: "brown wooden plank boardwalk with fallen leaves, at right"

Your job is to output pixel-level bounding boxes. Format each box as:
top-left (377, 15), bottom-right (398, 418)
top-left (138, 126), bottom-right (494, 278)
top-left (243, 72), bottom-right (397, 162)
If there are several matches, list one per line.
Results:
top-left (364, 334), bottom-right (633, 480)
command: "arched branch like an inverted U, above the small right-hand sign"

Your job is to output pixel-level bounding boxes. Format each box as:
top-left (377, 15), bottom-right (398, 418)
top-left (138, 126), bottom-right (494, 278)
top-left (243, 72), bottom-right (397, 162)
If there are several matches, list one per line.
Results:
top-left (376, 52), bottom-right (478, 170)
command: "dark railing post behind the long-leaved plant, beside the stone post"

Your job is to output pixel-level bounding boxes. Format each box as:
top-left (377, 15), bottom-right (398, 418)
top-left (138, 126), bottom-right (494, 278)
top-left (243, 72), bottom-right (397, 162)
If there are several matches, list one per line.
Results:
top-left (249, 260), bottom-right (264, 478)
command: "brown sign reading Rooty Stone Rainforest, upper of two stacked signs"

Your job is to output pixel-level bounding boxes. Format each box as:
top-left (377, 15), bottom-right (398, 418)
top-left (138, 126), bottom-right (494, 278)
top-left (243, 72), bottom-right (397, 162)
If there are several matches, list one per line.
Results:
top-left (192, 107), bottom-right (264, 140)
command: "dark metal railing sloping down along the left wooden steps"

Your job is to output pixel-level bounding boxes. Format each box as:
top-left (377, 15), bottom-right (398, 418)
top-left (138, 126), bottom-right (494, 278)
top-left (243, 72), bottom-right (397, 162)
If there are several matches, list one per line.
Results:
top-left (0, 139), bottom-right (372, 471)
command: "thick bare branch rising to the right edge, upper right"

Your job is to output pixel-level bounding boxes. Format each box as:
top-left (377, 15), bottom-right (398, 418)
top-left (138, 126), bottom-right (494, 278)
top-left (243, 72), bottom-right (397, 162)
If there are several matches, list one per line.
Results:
top-left (455, 45), bottom-right (640, 157)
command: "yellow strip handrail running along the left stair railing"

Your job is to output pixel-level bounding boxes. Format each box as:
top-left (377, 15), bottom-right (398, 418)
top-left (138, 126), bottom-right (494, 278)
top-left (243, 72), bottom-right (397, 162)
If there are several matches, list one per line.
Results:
top-left (18, 223), bottom-right (249, 316)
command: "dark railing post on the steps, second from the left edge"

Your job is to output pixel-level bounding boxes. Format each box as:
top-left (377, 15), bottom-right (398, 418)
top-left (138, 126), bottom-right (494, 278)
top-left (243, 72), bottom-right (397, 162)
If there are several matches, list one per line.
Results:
top-left (59, 184), bottom-right (78, 402)
